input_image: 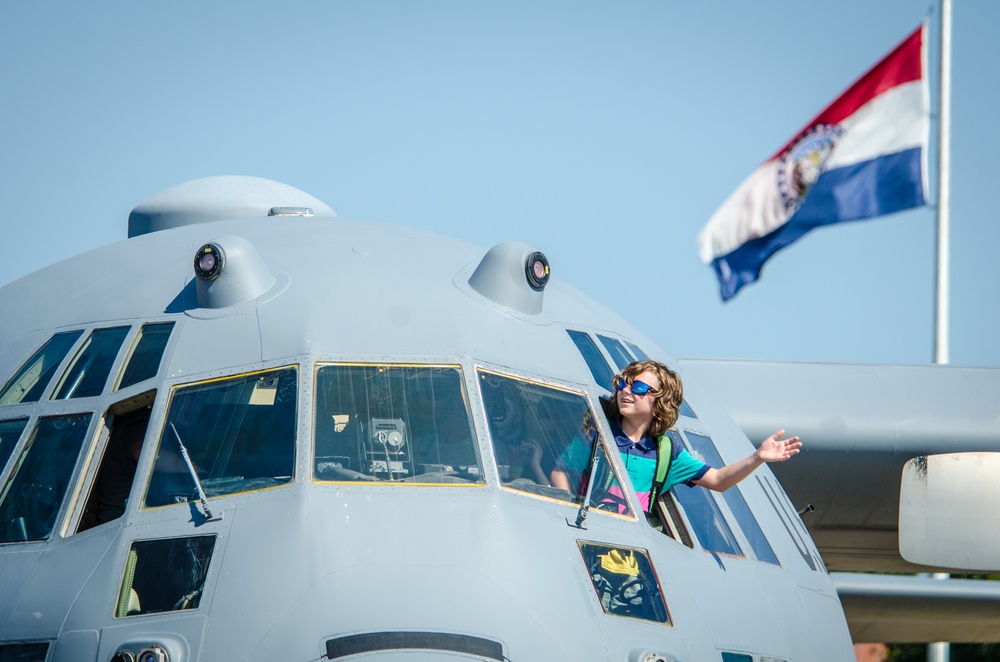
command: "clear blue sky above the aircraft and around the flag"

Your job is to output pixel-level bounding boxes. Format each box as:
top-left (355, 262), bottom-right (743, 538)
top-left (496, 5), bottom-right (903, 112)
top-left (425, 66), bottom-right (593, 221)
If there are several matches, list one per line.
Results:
top-left (0, 0), bottom-right (1000, 366)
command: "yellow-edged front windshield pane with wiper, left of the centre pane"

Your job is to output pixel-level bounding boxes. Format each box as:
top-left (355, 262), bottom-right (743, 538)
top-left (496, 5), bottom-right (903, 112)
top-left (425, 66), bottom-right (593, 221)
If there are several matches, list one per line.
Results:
top-left (144, 367), bottom-right (298, 507)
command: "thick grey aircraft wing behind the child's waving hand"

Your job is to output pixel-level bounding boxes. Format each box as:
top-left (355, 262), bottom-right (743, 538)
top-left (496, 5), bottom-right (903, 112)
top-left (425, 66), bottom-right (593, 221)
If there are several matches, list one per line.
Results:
top-left (680, 359), bottom-right (1000, 572)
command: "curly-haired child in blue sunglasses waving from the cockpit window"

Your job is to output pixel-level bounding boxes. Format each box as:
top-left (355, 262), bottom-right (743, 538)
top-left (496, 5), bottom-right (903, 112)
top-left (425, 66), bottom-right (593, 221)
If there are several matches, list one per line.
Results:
top-left (551, 360), bottom-right (802, 513)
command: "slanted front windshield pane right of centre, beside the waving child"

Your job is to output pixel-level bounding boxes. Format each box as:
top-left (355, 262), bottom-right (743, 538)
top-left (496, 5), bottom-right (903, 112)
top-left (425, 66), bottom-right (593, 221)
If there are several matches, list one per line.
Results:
top-left (479, 370), bottom-right (631, 513)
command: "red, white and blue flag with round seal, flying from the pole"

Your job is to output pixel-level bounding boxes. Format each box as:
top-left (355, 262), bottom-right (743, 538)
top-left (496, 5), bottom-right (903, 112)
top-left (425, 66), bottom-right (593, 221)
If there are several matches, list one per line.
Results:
top-left (698, 25), bottom-right (929, 301)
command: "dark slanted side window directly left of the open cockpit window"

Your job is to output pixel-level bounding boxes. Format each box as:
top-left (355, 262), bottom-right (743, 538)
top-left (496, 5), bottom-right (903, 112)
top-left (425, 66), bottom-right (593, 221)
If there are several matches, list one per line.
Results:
top-left (0, 414), bottom-right (92, 542)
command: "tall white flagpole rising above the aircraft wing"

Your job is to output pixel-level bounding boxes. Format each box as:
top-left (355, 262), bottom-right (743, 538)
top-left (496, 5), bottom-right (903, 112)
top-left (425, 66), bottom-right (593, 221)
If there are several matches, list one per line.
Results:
top-left (934, 0), bottom-right (951, 363)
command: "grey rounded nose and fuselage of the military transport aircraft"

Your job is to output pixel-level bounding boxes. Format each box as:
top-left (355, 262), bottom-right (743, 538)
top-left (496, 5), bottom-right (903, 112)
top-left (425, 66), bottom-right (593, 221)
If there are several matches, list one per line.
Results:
top-left (0, 177), bottom-right (996, 662)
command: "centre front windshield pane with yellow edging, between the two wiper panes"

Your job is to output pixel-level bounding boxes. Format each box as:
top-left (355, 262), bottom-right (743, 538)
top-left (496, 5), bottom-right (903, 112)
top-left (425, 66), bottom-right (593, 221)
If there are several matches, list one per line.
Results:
top-left (313, 365), bottom-right (483, 484)
